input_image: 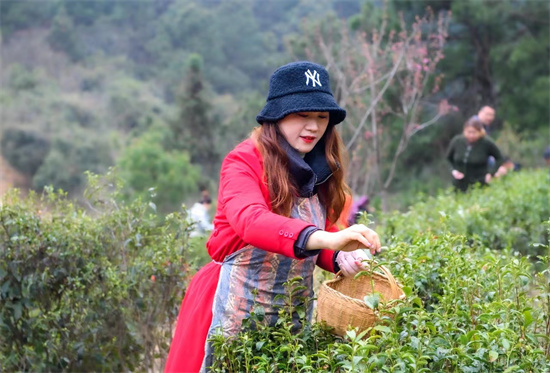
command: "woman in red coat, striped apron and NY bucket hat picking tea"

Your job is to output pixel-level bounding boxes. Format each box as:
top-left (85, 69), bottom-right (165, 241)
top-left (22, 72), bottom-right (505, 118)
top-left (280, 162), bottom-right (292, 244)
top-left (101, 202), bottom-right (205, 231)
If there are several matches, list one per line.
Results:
top-left (165, 61), bottom-right (380, 372)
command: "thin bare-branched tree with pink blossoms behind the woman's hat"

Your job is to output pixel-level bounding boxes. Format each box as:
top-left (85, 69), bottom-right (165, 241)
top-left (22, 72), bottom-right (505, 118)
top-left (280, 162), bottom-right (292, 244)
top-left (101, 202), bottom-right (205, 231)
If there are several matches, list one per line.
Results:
top-left (287, 8), bottom-right (456, 208)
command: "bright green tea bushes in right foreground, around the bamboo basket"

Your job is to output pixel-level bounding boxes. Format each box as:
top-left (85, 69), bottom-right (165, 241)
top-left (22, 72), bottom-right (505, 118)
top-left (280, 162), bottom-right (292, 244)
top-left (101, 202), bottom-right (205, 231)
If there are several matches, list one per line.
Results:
top-left (212, 230), bottom-right (550, 372)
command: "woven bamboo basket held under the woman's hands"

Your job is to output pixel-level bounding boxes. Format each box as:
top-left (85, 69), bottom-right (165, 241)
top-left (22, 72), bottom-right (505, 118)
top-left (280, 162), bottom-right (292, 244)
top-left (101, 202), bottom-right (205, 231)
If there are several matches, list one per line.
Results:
top-left (317, 266), bottom-right (405, 337)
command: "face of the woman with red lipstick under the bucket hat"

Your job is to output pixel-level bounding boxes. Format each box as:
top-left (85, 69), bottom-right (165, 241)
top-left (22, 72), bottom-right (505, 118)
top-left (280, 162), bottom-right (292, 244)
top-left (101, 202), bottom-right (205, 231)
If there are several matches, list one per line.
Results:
top-left (278, 111), bottom-right (329, 154)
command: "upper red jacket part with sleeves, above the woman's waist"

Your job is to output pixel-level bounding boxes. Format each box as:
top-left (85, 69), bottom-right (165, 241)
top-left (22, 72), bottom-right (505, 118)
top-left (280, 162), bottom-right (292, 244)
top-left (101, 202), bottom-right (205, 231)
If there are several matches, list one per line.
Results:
top-left (206, 139), bottom-right (337, 272)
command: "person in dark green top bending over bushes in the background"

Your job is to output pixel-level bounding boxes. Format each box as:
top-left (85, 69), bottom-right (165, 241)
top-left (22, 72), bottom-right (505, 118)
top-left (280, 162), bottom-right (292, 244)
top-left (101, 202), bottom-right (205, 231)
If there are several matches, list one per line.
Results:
top-left (447, 115), bottom-right (504, 192)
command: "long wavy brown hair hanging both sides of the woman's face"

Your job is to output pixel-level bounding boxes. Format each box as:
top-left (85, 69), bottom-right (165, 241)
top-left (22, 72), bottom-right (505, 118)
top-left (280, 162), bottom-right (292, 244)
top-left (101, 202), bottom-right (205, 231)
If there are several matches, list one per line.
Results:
top-left (250, 122), bottom-right (350, 223)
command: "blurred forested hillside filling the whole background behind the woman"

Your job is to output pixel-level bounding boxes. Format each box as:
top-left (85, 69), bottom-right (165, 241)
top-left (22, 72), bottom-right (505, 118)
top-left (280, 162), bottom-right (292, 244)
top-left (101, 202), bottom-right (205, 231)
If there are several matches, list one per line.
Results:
top-left (0, 0), bottom-right (550, 211)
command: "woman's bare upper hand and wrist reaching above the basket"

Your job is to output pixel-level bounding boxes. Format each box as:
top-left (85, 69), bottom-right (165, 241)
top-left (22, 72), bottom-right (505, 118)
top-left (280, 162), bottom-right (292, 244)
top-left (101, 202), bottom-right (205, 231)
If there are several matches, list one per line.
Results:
top-left (306, 224), bottom-right (380, 255)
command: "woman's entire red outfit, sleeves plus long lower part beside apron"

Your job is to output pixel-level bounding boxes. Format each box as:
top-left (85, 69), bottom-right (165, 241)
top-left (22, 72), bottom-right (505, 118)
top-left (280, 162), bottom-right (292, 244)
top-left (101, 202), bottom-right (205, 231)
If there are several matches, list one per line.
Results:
top-left (165, 139), bottom-right (338, 372)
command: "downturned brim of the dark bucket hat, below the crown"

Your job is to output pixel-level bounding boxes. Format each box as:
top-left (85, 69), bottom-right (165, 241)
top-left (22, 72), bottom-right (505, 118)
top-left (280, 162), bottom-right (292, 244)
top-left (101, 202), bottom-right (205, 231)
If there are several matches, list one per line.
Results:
top-left (256, 92), bottom-right (346, 124)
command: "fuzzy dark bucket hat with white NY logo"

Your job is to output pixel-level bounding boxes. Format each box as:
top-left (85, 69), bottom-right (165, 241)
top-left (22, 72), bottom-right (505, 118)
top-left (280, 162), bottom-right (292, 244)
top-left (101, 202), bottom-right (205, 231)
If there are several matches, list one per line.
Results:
top-left (256, 61), bottom-right (346, 124)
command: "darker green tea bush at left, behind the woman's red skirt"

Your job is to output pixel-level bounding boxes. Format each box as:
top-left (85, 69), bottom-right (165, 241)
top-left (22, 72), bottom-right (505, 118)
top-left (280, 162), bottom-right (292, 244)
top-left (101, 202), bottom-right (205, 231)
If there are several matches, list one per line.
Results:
top-left (0, 176), bottom-right (194, 372)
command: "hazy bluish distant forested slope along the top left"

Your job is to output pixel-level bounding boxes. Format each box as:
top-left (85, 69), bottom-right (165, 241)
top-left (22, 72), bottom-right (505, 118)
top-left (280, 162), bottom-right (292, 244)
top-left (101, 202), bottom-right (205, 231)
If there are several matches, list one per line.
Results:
top-left (1, 0), bottom-right (361, 94)
